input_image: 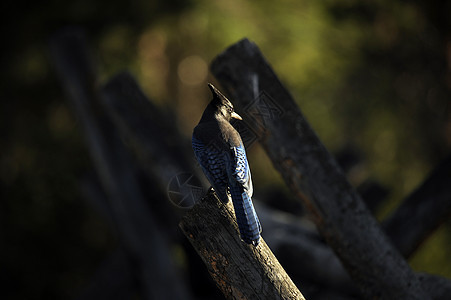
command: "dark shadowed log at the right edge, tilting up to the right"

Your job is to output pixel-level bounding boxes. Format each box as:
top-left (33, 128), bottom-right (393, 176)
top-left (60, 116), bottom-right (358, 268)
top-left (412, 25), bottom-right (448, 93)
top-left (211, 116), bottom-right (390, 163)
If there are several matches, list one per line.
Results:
top-left (382, 156), bottom-right (451, 257)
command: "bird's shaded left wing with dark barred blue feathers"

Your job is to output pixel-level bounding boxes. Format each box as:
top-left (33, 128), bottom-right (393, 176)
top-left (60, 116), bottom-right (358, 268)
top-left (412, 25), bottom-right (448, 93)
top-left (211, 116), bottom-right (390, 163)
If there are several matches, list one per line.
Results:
top-left (192, 136), bottom-right (229, 203)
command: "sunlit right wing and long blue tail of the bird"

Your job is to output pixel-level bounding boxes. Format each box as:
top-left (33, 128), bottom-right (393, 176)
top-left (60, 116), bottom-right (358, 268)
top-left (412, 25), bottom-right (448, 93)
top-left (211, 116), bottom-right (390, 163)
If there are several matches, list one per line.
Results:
top-left (227, 144), bottom-right (262, 245)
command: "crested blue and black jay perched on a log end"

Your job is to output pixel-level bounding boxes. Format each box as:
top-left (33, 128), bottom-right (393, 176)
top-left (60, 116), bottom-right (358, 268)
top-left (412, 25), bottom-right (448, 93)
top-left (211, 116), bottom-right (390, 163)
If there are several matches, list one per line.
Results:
top-left (192, 83), bottom-right (262, 246)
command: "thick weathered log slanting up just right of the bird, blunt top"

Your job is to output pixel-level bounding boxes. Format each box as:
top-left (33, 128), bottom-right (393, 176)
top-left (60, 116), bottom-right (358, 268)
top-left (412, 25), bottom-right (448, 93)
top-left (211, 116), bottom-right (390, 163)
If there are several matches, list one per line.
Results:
top-left (211, 39), bottom-right (429, 299)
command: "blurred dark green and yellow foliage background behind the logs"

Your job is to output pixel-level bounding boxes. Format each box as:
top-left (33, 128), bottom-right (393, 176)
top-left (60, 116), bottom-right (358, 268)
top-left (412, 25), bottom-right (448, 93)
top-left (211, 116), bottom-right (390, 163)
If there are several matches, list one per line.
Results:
top-left (0, 0), bottom-right (451, 299)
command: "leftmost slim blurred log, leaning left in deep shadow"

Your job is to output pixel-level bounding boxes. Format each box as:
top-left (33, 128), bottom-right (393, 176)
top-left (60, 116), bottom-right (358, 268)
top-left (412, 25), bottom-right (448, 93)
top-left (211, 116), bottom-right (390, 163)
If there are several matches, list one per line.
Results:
top-left (51, 30), bottom-right (190, 299)
